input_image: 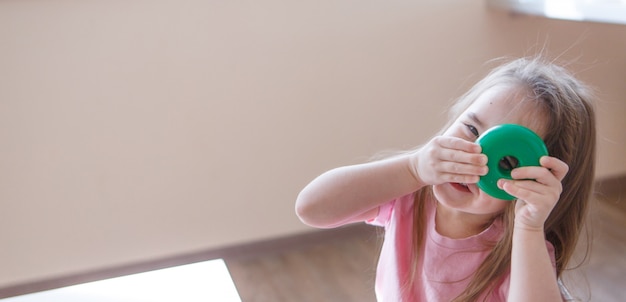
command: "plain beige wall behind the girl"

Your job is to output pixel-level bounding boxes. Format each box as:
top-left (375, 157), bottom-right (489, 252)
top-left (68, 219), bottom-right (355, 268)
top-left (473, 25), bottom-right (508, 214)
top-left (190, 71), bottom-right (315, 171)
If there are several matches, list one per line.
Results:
top-left (0, 0), bottom-right (626, 287)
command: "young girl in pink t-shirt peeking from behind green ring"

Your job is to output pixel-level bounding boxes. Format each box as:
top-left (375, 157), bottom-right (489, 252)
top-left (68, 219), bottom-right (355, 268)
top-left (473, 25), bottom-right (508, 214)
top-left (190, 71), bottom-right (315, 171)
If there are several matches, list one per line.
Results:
top-left (296, 58), bottom-right (595, 302)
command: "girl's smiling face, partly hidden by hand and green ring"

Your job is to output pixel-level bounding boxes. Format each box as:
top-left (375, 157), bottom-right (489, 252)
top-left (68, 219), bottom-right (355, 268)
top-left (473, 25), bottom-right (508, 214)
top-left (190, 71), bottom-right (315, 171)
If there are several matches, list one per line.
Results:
top-left (433, 86), bottom-right (546, 216)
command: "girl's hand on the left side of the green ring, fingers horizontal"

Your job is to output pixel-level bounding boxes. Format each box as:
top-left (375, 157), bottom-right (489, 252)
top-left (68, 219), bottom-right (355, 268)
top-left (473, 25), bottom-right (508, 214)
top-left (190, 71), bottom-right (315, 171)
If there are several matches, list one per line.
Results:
top-left (410, 136), bottom-right (488, 185)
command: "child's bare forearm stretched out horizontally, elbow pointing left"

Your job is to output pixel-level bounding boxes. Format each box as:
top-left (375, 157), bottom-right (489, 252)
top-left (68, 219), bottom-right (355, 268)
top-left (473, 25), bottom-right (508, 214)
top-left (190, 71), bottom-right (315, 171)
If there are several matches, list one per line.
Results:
top-left (296, 156), bottom-right (422, 227)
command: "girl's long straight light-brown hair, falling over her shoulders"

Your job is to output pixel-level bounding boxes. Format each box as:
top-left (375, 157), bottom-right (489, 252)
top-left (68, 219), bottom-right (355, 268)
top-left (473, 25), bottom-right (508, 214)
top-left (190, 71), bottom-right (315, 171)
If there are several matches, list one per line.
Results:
top-left (407, 57), bottom-right (596, 301)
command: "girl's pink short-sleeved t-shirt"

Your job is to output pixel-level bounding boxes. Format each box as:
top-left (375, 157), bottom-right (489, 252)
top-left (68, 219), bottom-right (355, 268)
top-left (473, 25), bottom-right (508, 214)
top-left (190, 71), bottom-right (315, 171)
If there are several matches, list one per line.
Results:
top-left (368, 194), bottom-right (555, 302)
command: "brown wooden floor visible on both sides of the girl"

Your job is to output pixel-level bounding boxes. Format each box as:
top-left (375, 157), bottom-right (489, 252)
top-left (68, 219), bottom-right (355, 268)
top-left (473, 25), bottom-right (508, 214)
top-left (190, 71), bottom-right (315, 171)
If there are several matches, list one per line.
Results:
top-left (226, 196), bottom-right (626, 302)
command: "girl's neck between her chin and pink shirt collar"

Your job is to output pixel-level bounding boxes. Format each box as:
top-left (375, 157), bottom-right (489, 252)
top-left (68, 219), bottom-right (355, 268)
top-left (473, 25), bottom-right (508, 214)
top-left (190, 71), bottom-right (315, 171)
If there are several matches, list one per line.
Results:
top-left (435, 202), bottom-right (493, 239)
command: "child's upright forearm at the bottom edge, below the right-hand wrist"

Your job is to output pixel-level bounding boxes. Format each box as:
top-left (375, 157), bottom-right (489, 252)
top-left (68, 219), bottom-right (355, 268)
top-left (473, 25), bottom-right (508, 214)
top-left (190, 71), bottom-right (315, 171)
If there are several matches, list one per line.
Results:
top-left (507, 227), bottom-right (562, 302)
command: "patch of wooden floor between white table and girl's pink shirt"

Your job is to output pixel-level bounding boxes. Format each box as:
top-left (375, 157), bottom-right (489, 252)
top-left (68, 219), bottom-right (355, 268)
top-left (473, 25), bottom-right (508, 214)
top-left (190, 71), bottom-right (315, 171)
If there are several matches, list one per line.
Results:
top-left (226, 226), bottom-right (382, 302)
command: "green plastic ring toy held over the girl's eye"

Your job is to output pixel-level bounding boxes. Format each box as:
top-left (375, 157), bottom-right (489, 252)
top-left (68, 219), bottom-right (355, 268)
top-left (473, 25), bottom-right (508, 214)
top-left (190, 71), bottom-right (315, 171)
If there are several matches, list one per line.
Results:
top-left (476, 124), bottom-right (548, 200)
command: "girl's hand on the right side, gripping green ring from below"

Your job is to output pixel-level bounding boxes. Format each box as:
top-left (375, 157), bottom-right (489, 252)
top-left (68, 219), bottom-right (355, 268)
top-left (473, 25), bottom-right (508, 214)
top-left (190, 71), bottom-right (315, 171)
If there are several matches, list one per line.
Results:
top-left (498, 156), bottom-right (569, 230)
